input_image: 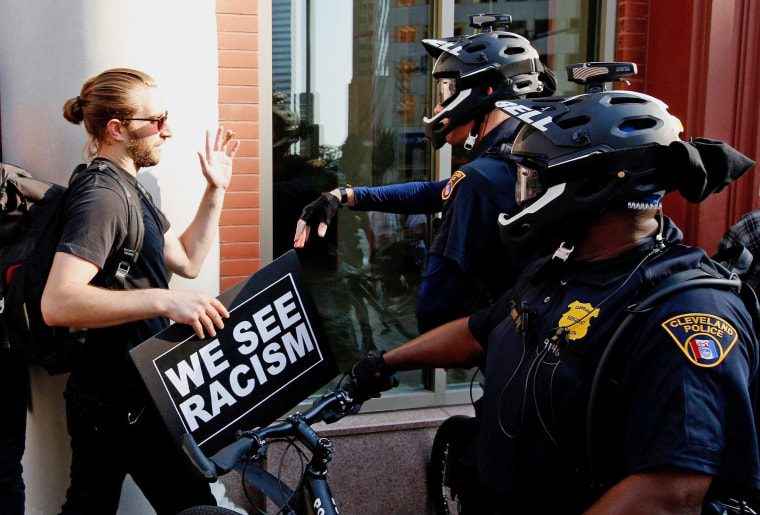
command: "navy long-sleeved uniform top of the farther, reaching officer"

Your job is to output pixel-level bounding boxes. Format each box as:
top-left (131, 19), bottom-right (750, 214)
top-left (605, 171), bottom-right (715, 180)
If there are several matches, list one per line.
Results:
top-left (354, 118), bottom-right (520, 332)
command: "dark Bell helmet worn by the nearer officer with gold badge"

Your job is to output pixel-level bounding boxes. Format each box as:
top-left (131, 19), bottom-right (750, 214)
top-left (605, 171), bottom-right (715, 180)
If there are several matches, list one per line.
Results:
top-left (497, 91), bottom-right (683, 254)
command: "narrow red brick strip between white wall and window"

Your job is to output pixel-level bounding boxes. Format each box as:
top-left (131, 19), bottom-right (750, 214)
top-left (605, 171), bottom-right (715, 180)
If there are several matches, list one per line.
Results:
top-left (216, 0), bottom-right (260, 291)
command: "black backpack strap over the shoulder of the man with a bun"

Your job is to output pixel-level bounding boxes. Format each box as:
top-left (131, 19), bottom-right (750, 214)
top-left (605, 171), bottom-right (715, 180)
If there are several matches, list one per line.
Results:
top-left (69, 161), bottom-right (145, 289)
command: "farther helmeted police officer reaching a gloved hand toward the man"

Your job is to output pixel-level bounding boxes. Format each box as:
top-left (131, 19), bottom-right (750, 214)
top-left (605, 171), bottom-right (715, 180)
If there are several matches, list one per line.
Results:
top-left (294, 15), bottom-right (556, 331)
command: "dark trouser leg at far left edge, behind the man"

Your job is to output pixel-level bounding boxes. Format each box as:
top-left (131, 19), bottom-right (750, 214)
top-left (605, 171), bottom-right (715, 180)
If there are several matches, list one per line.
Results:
top-left (0, 349), bottom-right (29, 515)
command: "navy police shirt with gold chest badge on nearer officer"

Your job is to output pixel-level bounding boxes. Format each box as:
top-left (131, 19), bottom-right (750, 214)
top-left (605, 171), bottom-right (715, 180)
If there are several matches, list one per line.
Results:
top-left (470, 219), bottom-right (760, 513)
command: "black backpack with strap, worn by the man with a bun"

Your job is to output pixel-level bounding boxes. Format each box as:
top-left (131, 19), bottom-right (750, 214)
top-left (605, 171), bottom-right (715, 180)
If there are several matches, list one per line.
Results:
top-left (0, 161), bottom-right (144, 375)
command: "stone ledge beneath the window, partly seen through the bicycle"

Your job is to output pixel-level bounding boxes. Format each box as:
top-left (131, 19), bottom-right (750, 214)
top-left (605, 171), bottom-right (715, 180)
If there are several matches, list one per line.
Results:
top-left (222, 405), bottom-right (474, 515)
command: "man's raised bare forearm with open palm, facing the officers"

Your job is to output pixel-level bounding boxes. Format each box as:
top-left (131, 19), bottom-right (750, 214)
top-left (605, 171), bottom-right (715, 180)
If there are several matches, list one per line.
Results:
top-left (164, 127), bottom-right (240, 278)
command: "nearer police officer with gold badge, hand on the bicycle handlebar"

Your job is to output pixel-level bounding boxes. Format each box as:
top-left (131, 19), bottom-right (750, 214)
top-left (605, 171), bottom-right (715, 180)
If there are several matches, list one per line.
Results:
top-left (341, 91), bottom-right (760, 513)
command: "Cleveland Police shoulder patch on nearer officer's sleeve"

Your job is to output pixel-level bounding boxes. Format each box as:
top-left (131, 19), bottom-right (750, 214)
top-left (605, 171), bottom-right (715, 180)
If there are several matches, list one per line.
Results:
top-left (662, 313), bottom-right (739, 368)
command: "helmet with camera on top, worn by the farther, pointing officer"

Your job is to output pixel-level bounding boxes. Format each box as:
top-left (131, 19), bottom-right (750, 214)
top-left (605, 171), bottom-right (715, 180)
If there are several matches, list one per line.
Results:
top-left (422, 15), bottom-right (556, 149)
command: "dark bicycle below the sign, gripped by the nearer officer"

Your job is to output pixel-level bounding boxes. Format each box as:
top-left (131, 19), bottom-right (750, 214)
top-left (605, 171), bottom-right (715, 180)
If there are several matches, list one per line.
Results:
top-left (178, 388), bottom-right (361, 515)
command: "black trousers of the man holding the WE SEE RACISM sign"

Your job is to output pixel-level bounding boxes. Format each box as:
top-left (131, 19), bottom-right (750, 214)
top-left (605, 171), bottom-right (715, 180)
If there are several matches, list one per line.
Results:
top-left (57, 383), bottom-right (216, 515)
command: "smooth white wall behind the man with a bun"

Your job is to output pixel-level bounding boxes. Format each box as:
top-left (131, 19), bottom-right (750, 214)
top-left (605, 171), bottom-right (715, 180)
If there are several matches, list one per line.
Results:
top-left (0, 0), bottom-right (219, 515)
